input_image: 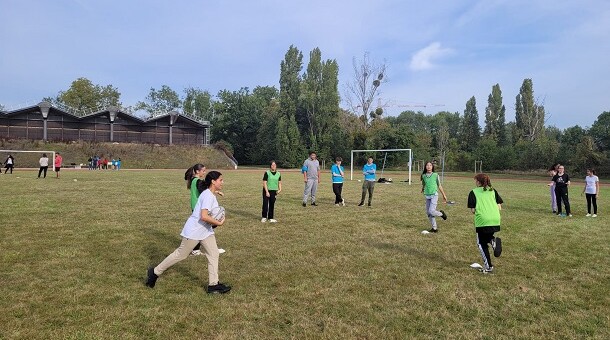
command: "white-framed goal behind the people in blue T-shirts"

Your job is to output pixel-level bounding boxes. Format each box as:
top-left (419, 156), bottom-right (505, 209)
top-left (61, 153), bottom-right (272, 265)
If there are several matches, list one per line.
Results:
top-left (350, 149), bottom-right (413, 185)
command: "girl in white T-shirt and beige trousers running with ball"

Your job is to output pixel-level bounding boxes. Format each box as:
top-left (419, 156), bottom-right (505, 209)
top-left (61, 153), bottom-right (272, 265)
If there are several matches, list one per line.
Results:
top-left (146, 171), bottom-right (231, 294)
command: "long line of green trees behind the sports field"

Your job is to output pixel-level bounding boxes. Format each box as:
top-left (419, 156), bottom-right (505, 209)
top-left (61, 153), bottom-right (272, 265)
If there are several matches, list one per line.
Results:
top-left (21, 46), bottom-right (610, 174)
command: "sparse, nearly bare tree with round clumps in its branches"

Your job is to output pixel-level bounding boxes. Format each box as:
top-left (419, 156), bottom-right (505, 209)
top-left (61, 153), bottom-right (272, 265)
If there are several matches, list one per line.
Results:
top-left (345, 52), bottom-right (387, 127)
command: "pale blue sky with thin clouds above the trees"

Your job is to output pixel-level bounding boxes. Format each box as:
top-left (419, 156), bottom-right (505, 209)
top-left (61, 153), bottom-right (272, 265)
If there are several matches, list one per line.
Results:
top-left (0, 0), bottom-right (610, 128)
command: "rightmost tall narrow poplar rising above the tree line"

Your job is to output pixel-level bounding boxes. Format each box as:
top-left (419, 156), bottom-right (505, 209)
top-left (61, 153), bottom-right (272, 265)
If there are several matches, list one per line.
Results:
top-left (515, 79), bottom-right (546, 142)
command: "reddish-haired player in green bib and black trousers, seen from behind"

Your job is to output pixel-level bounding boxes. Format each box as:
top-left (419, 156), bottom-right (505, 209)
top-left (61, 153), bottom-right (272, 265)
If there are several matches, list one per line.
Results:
top-left (468, 174), bottom-right (504, 273)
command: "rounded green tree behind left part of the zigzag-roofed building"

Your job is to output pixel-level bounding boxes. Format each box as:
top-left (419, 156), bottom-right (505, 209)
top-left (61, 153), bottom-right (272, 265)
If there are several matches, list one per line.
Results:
top-left (54, 78), bottom-right (121, 112)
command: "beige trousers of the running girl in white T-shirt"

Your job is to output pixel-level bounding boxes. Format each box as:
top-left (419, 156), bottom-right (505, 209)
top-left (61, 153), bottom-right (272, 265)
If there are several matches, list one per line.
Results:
top-left (155, 235), bottom-right (220, 286)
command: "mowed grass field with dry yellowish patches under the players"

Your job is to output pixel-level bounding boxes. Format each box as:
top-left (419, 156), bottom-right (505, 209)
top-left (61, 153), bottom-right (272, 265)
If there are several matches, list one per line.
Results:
top-left (0, 169), bottom-right (610, 339)
